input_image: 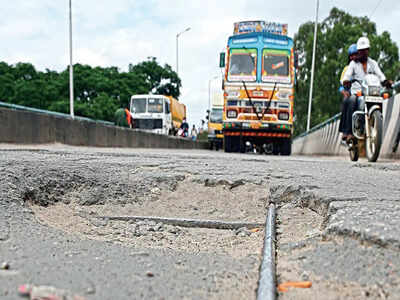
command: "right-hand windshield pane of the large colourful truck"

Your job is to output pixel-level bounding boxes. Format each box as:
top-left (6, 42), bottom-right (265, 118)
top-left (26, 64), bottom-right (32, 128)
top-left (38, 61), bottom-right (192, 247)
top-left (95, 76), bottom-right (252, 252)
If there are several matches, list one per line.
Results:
top-left (262, 49), bottom-right (290, 83)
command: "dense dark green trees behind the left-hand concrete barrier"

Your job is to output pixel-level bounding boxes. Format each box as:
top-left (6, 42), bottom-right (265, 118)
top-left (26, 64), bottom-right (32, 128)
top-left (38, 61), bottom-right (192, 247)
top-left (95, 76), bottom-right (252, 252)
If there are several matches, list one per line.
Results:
top-left (0, 57), bottom-right (181, 121)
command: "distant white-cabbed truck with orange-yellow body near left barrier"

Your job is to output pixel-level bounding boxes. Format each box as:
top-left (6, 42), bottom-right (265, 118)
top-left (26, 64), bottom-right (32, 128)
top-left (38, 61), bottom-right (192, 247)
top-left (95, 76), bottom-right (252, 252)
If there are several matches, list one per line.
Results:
top-left (130, 95), bottom-right (186, 135)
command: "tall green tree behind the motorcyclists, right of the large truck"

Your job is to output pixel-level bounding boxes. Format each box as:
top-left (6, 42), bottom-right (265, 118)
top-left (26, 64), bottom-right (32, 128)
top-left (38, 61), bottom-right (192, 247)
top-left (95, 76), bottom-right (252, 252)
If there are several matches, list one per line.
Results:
top-left (294, 8), bottom-right (400, 135)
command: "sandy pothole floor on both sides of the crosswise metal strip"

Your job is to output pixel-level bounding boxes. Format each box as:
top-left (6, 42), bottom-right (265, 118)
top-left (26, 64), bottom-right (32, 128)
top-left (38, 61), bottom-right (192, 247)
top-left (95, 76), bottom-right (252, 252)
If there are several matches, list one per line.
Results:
top-left (31, 180), bottom-right (267, 257)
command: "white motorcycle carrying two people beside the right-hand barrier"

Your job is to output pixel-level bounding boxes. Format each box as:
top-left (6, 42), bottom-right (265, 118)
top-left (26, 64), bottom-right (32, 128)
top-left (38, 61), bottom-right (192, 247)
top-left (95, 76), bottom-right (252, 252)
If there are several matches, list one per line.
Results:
top-left (347, 74), bottom-right (393, 162)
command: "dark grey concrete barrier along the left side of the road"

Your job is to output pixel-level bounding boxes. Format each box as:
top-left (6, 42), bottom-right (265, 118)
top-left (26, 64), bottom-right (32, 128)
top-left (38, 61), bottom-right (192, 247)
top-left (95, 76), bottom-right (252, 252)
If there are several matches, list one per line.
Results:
top-left (0, 102), bottom-right (208, 149)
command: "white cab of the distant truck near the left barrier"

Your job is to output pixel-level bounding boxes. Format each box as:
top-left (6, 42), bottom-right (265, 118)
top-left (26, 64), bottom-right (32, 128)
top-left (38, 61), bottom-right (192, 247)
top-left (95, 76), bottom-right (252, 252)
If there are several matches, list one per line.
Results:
top-left (130, 95), bottom-right (170, 130)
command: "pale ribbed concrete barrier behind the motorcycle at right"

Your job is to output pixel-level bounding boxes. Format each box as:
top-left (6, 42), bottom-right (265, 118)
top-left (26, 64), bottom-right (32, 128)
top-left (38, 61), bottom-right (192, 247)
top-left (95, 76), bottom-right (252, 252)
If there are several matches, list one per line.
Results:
top-left (292, 94), bottom-right (400, 158)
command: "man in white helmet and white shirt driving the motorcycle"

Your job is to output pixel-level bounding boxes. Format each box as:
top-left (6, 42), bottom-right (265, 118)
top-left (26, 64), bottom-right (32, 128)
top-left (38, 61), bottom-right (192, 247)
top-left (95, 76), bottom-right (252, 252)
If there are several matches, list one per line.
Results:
top-left (341, 37), bottom-right (393, 140)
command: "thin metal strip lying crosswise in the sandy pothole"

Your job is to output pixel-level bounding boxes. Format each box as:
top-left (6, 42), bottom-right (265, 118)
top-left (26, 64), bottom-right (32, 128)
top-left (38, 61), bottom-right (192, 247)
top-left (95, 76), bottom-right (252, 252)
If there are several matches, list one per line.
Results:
top-left (97, 216), bottom-right (265, 229)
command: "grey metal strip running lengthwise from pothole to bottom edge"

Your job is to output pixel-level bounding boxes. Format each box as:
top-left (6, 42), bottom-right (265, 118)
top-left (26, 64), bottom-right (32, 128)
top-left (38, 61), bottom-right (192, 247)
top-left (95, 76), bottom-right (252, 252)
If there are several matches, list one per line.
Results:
top-left (257, 203), bottom-right (276, 300)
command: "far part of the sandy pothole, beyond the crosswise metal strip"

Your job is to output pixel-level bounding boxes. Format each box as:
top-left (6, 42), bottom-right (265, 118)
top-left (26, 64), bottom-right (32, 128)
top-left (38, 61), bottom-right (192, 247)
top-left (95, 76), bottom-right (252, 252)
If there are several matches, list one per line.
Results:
top-left (27, 180), bottom-right (268, 222)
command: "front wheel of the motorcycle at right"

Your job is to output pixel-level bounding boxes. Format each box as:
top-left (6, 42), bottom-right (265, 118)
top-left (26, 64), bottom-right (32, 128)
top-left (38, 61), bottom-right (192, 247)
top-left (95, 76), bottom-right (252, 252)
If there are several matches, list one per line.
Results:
top-left (365, 110), bottom-right (383, 162)
